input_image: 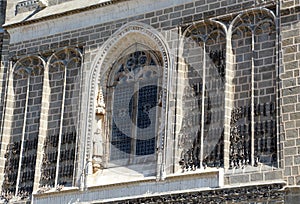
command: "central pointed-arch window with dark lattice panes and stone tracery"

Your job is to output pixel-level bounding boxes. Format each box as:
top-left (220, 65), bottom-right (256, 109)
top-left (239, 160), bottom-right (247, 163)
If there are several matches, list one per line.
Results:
top-left (108, 44), bottom-right (161, 165)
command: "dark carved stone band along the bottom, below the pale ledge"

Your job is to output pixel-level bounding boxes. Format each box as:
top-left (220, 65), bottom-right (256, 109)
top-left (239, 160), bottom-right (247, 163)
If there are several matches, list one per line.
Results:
top-left (102, 182), bottom-right (286, 203)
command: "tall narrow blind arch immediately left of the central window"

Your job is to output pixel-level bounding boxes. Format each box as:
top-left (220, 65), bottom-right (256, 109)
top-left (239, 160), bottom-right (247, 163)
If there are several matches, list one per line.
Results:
top-left (35, 47), bottom-right (83, 190)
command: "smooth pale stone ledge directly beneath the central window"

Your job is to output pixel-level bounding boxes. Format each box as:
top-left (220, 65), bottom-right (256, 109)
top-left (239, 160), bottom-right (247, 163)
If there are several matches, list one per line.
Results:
top-left (33, 169), bottom-right (224, 203)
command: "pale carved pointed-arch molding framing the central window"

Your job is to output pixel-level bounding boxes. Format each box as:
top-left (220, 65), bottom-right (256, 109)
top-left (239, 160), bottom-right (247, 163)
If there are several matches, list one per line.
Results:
top-left (81, 22), bottom-right (173, 185)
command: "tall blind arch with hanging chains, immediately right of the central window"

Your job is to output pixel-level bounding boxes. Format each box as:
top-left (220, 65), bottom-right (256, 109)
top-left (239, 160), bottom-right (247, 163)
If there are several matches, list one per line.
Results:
top-left (174, 20), bottom-right (227, 171)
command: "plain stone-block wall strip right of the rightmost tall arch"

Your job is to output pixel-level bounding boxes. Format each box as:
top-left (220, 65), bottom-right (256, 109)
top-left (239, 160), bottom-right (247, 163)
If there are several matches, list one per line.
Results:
top-left (280, 1), bottom-right (300, 185)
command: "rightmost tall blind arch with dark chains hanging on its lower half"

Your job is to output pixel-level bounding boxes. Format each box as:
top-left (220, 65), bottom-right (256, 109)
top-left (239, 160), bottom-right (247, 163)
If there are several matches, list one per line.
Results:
top-left (228, 8), bottom-right (278, 168)
